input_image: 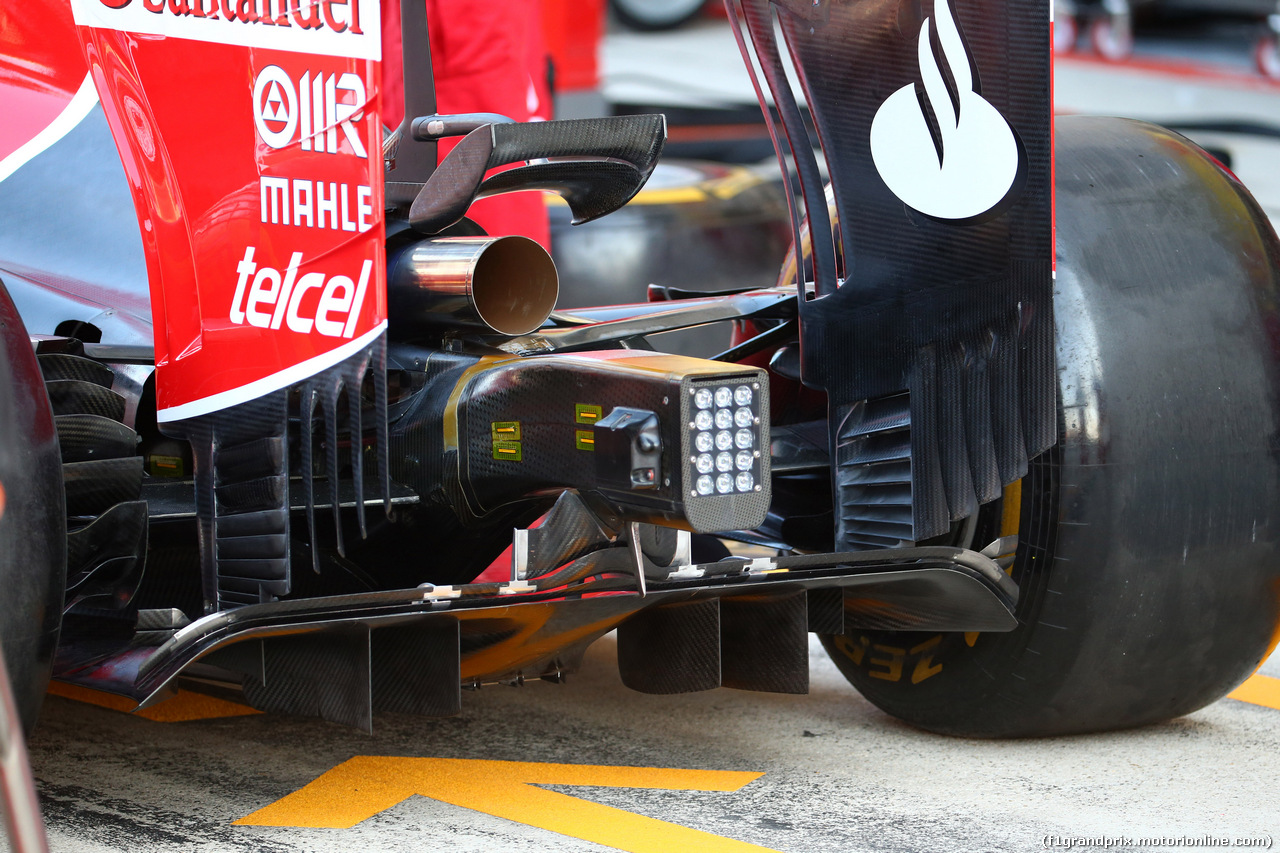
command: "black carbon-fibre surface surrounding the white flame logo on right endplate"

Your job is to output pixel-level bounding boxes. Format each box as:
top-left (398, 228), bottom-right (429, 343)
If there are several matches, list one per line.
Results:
top-left (731, 0), bottom-right (1056, 547)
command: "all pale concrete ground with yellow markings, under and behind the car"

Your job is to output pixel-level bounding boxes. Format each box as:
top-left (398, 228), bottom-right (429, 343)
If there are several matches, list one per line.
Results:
top-left (10, 9), bottom-right (1280, 853)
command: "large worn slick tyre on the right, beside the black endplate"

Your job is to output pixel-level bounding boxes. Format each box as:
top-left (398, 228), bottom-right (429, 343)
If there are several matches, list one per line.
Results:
top-left (823, 118), bottom-right (1280, 736)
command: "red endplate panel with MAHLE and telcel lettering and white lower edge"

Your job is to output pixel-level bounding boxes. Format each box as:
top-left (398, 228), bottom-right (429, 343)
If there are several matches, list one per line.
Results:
top-left (72, 0), bottom-right (387, 424)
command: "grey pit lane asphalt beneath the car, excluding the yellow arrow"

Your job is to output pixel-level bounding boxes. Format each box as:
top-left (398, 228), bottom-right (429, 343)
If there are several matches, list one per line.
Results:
top-left (17, 638), bottom-right (1280, 853)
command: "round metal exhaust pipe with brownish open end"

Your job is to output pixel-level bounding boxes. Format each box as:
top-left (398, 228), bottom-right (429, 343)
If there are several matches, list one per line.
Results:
top-left (387, 237), bottom-right (559, 337)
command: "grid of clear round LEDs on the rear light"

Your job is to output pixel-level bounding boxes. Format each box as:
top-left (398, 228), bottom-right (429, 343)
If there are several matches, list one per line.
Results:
top-left (685, 379), bottom-right (763, 498)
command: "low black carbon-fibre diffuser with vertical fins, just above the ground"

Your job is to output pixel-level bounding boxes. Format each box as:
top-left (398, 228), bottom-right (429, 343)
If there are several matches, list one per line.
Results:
top-left (55, 548), bottom-right (1018, 730)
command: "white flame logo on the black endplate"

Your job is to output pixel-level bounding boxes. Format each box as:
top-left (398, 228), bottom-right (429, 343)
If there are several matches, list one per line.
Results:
top-left (870, 0), bottom-right (1019, 220)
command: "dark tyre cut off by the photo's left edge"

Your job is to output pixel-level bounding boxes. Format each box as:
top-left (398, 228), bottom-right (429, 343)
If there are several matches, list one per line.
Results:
top-left (0, 283), bottom-right (67, 731)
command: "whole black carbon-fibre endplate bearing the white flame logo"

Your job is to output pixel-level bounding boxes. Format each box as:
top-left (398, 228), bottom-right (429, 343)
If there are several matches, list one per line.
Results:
top-left (728, 0), bottom-right (1057, 540)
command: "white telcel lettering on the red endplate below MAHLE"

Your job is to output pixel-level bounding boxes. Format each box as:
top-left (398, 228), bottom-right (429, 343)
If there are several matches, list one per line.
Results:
top-left (230, 246), bottom-right (374, 338)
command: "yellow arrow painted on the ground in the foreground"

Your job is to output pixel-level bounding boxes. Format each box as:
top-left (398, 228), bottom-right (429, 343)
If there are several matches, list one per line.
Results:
top-left (236, 756), bottom-right (776, 853)
